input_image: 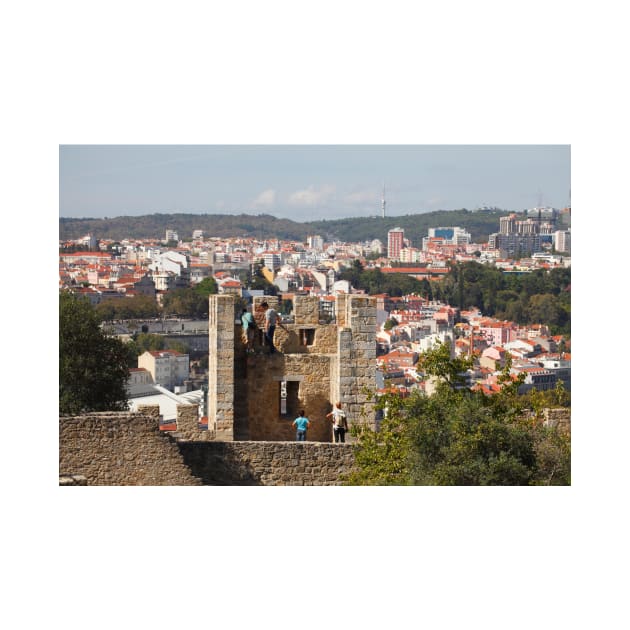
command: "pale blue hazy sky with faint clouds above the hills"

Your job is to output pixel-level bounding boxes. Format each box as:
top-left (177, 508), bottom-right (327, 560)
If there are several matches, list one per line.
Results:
top-left (59, 144), bottom-right (571, 221)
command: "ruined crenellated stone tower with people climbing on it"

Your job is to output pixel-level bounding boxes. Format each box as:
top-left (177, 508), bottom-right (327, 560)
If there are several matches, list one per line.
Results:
top-left (208, 295), bottom-right (376, 442)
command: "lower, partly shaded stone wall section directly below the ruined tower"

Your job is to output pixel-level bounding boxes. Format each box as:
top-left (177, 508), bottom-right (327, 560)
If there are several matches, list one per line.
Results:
top-left (179, 442), bottom-right (354, 486)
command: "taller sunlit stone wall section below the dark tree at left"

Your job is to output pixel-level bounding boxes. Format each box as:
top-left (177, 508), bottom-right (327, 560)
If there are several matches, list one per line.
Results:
top-left (59, 406), bottom-right (201, 486)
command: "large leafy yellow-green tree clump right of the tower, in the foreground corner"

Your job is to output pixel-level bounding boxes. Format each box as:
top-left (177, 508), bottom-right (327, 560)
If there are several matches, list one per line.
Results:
top-left (346, 344), bottom-right (571, 485)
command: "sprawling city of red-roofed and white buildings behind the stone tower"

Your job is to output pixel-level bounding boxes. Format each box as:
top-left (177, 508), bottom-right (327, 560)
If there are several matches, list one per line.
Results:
top-left (59, 200), bottom-right (571, 472)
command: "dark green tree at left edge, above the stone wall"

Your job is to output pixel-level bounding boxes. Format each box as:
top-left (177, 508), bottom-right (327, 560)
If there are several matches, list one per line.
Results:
top-left (59, 291), bottom-right (129, 415)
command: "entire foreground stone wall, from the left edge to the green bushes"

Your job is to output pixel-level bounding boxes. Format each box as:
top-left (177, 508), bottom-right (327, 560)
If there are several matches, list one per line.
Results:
top-left (59, 405), bottom-right (354, 486)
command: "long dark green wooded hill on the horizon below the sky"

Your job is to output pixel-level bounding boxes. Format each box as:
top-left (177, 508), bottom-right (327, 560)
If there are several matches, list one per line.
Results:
top-left (59, 210), bottom-right (507, 246)
